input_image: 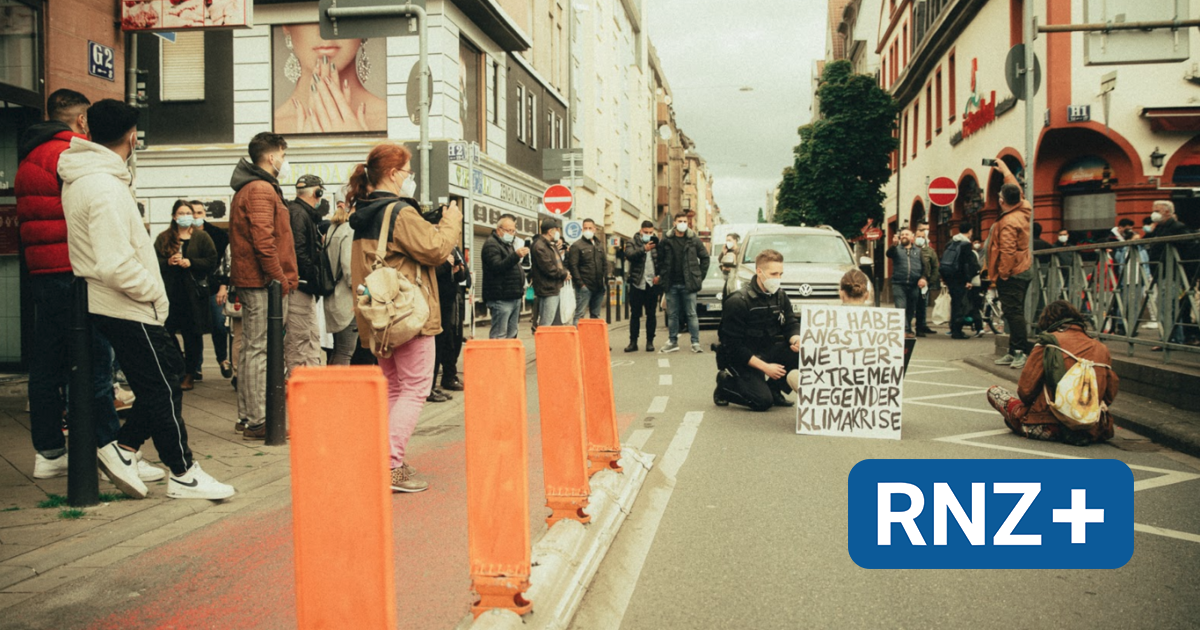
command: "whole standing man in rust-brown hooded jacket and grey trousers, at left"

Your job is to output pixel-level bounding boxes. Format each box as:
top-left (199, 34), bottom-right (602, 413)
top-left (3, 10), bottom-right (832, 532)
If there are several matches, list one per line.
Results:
top-left (229, 132), bottom-right (300, 439)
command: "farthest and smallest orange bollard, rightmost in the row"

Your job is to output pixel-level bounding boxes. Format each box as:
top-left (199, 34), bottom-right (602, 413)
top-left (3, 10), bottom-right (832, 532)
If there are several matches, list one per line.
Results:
top-left (576, 319), bottom-right (620, 475)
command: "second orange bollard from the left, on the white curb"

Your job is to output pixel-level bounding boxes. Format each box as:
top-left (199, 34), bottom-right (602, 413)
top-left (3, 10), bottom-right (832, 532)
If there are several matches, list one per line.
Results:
top-left (463, 340), bottom-right (533, 617)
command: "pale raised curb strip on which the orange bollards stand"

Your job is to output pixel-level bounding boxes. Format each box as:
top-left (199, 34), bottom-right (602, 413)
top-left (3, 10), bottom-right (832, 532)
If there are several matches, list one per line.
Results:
top-left (456, 446), bottom-right (654, 630)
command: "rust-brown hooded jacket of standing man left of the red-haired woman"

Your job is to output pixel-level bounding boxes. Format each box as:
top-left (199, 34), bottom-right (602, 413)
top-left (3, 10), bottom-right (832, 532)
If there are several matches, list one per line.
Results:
top-left (229, 157), bottom-right (300, 295)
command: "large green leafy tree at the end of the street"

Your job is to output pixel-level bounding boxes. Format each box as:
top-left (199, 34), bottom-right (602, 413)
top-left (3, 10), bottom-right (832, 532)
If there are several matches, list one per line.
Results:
top-left (775, 60), bottom-right (898, 234)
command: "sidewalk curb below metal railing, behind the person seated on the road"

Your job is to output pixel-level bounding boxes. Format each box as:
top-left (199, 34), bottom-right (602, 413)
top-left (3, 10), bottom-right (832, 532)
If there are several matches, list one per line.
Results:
top-left (962, 354), bottom-right (1200, 457)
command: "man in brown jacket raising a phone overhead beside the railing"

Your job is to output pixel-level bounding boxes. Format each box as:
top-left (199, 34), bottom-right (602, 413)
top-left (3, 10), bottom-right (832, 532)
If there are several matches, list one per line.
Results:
top-left (988, 157), bottom-right (1033, 370)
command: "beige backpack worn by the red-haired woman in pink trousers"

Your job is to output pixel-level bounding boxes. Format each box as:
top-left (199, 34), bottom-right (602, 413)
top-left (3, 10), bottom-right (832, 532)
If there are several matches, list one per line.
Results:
top-left (354, 203), bottom-right (430, 359)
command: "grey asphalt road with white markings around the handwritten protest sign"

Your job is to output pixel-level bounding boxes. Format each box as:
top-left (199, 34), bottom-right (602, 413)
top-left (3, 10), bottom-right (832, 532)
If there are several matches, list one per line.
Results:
top-left (572, 332), bottom-right (1200, 630)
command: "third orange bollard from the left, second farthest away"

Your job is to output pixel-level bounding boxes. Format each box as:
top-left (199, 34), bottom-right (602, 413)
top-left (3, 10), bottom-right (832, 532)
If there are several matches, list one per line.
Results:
top-left (534, 326), bottom-right (592, 526)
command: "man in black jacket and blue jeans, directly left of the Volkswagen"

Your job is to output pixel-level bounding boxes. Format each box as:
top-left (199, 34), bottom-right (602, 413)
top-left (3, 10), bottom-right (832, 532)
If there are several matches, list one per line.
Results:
top-left (656, 212), bottom-right (709, 353)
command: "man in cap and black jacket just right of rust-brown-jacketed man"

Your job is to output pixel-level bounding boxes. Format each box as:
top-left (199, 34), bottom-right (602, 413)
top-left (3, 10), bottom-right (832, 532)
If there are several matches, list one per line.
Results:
top-left (283, 175), bottom-right (329, 374)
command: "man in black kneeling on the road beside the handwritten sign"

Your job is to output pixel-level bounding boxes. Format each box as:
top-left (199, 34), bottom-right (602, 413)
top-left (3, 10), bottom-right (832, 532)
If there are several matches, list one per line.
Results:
top-left (713, 250), bottom-right (800, 412)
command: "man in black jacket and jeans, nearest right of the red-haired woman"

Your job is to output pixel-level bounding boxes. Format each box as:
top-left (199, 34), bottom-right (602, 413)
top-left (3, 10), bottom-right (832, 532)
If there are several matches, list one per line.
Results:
top-left (482, 215), bottom-right (529, 340)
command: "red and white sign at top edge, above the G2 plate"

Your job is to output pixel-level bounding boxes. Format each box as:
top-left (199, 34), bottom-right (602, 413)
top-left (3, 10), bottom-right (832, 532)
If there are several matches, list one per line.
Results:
top-left (121, 0), bottom-right (253, 31)
